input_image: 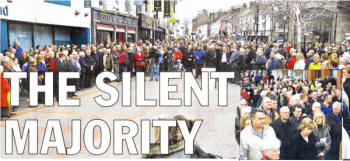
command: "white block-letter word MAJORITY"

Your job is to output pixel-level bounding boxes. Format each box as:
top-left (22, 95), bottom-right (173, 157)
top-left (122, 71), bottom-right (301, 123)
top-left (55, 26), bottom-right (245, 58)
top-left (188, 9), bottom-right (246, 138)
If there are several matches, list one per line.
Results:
top-left (5, 120), bottom-right (202, 155)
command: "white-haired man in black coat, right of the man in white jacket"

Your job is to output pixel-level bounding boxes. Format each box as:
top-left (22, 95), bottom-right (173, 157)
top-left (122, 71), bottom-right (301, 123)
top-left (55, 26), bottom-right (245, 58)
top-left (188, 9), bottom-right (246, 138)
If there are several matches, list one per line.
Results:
top-left (270, 106), bottom-right (296, 160)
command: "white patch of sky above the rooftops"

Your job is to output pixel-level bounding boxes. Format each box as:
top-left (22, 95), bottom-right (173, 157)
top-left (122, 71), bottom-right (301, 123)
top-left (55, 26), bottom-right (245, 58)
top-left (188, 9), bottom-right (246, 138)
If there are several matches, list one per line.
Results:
top-left (175, 0), bottom-right (249, 24)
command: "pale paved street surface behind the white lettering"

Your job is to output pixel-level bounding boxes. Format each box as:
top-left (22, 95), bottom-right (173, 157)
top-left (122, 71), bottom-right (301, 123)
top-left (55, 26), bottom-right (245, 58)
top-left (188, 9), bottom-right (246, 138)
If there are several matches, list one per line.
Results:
top-left (0, 74), bottom-right (240, 159)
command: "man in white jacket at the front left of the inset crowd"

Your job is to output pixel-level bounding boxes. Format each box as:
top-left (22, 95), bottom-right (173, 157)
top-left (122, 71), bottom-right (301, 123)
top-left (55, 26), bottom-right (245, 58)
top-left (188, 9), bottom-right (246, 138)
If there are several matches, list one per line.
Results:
top-left (240, 108), bottom-right (277, 160)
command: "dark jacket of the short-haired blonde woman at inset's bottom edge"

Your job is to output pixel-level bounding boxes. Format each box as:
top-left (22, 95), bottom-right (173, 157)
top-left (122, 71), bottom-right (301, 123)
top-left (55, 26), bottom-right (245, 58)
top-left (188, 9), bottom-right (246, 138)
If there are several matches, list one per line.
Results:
top-left (289, 131), bottom-right (317, 160)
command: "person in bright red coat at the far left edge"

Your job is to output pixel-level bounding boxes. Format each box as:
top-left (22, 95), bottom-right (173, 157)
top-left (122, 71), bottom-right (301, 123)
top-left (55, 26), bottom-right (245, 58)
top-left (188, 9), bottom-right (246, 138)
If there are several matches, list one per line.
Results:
top-left (0, 65), bottom-right (10, 120)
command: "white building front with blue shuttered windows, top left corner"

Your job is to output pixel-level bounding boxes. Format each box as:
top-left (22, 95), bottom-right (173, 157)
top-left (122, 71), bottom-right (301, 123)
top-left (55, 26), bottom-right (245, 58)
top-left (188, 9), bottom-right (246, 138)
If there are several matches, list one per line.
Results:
top-left (0, 0), bottom-right (91, 51)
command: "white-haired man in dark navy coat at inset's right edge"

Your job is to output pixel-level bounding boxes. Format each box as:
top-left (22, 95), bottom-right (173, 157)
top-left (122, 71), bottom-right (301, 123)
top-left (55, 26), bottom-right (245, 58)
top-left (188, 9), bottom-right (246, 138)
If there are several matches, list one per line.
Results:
top-left (326, 102), bottom-right (342, 160)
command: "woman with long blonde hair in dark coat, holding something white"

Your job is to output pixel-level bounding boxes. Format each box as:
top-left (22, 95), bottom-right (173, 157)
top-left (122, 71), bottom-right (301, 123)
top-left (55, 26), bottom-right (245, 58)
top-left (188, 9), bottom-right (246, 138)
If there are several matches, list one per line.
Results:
top-left (312, 111), bottom-right (331, 160)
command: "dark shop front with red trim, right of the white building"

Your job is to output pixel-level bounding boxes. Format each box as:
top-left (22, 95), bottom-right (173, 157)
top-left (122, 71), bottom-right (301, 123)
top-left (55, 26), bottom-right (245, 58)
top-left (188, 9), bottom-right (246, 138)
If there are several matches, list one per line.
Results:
top-left (91, 8), bottom-right (138, 44)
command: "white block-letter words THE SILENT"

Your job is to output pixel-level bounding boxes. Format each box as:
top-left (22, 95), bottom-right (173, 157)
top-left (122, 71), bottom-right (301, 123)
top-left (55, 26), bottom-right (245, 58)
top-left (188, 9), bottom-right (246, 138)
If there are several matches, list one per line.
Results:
top-left (4, 72), bottom-right (234, 107)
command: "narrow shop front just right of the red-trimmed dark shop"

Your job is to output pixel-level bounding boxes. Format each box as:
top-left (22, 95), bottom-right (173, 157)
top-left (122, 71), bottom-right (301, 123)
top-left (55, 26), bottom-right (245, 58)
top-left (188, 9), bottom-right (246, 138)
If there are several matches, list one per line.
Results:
top-left (139, 14), bottom-right (157, 41)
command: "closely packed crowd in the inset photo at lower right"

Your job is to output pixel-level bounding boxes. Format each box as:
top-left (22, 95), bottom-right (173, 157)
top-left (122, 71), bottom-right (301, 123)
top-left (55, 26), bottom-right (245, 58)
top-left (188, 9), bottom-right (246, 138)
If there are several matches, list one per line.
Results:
top-left (235, 69), bottom-right (350, 160)
